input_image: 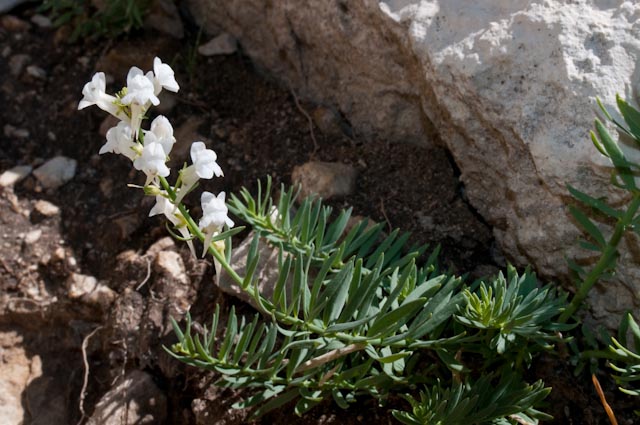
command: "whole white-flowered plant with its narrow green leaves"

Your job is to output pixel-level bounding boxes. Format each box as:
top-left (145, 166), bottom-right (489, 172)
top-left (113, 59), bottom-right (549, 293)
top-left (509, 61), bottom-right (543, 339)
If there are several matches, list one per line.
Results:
top-left (79, 58), bottom-right (571, 424)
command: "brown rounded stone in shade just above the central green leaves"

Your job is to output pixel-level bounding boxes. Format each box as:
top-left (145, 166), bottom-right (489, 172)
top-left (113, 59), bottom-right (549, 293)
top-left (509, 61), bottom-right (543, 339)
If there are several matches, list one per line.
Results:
top-left (291, 161), bottom-right (358, 199)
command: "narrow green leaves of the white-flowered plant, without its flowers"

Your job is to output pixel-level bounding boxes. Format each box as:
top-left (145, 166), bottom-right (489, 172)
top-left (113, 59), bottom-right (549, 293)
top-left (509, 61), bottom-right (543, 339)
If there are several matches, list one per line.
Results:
top-left (169, 180), bottom-right (565, 423)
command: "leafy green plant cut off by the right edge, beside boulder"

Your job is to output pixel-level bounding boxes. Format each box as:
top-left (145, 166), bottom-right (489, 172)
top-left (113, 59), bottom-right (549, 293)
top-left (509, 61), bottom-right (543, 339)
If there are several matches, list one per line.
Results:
top-left (560, 96), bottom-right (640, 414)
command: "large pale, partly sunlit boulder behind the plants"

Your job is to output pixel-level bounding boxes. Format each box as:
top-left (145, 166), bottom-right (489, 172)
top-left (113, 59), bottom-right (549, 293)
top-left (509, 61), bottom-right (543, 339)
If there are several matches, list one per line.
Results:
top-left (188, 0), bottom-right (640, 325)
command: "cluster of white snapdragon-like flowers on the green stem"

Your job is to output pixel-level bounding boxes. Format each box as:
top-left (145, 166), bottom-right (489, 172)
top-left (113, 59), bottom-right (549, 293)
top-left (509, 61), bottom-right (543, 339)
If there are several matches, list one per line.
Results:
top-left (78, 58), bottom-right (234, 256)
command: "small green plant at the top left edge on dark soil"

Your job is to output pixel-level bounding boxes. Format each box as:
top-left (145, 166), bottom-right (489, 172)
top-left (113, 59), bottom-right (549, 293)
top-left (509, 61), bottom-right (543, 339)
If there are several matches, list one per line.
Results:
top-left (39, 0), bottom-right (151, 42)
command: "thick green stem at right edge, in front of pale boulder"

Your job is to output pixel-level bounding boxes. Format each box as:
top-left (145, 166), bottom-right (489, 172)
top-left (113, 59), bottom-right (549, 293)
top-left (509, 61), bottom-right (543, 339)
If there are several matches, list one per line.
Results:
top-left (559, 193), bottom-right (640, 323)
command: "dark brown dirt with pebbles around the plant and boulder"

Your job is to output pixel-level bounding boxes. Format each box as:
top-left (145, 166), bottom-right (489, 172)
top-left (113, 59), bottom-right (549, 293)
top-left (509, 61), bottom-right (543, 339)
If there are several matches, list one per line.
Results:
top-left (0, 7), bottom-right (631, 424)
